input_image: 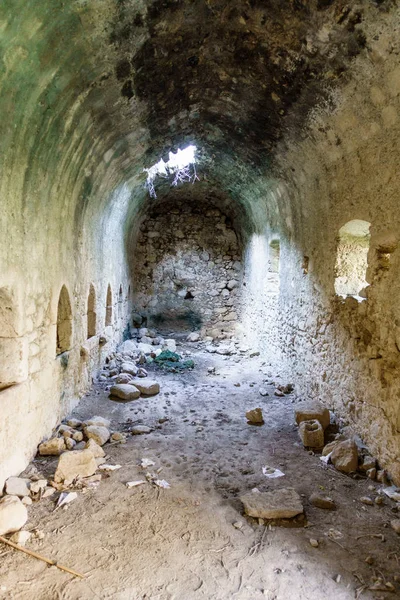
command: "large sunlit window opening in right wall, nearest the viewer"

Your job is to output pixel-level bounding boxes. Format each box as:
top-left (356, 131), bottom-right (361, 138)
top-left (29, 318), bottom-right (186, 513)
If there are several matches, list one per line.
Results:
top-left (335, 219), bottom-right (371, 302)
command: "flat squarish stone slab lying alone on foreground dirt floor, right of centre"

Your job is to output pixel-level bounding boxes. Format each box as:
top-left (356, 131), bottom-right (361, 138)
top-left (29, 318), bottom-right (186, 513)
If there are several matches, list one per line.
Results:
top-left (240, 488), bottom-right (303, 519)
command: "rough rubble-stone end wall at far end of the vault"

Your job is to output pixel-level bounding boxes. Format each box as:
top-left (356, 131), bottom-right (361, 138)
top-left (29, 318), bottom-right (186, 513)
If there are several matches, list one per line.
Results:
top-left (134, 199), bottom-right (242, 337)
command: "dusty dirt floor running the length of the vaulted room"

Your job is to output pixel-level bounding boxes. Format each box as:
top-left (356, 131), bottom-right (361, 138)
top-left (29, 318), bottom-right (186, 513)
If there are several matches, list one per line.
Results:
top-left (0, 345), bottom-right (400, 600)
